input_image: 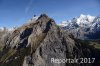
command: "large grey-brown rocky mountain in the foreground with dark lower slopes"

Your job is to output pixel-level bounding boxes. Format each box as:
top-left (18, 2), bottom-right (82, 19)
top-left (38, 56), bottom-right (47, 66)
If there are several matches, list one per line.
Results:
top-left (0, 14), bottom-right (100, 66)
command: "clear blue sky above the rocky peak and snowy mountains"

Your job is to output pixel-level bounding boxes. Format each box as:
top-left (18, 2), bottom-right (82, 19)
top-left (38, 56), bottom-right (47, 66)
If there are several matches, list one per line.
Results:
top-left (0, 0), bottom-right (100, 28)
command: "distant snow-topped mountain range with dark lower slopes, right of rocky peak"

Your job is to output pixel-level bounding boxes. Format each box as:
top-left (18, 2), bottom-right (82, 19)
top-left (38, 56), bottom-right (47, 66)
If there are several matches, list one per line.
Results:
top-left (59, 14), bottom-right (100, 39)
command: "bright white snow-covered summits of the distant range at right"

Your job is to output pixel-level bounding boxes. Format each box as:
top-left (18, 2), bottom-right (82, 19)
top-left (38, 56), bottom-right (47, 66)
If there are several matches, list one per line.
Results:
top-left (59, 14), bottom-right (95, 27)
